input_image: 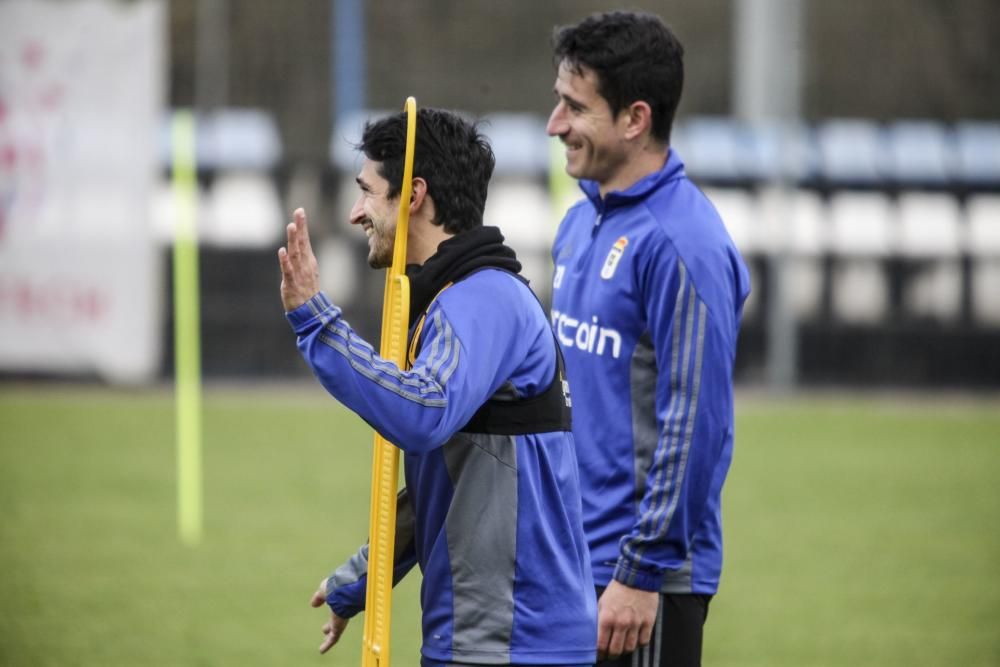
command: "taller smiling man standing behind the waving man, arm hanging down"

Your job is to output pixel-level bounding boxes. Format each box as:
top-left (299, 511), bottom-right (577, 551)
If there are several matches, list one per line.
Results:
top-left (548, 12), bottom-right (749, 667)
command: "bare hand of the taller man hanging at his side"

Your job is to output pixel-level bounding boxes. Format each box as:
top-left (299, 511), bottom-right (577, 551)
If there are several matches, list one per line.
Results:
top-left (597, 580), bottom-right (660, 660)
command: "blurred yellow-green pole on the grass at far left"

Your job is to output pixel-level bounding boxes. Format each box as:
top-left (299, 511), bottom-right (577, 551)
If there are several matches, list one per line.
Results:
top-left (171, 111), bottom-right (202, 546)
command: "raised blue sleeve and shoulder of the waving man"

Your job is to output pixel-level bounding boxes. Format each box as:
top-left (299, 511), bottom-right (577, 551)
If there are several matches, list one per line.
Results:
top-left (287, 271), bottom-right (551, 453)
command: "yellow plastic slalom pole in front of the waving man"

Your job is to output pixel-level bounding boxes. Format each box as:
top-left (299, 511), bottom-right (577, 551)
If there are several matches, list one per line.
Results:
top-left (361, 97), bottom-right (417, 667)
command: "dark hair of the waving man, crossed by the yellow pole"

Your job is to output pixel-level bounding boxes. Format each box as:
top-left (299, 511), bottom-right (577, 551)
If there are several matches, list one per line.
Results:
top-left (357, 109), bottom-right (496, 234)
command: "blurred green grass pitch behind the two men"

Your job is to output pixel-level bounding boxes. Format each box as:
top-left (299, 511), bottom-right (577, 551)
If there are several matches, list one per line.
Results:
top-left (0, 385), bottom-right (1000, 667)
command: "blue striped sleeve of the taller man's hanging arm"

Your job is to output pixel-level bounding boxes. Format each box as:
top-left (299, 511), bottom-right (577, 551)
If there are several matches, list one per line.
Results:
top-left (614, 241), bottom-right (734, 590)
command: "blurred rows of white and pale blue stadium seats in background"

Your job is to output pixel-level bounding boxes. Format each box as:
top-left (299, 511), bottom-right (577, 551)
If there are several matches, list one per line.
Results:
top-left (151, 110), bottom-right (1000, 383)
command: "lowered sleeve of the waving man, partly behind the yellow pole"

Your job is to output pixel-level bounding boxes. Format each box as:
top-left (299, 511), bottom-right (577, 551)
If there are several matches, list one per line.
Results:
top-left (326, 489), bottom-right (417, 618)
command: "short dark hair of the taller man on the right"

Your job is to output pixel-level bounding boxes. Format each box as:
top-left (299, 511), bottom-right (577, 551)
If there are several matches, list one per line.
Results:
top-left (552, 12), bottom-right (684, 142)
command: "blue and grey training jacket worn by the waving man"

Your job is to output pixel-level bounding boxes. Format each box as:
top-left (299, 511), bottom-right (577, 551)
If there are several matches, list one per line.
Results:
top-left (288, 269), bottom-right (597, 664)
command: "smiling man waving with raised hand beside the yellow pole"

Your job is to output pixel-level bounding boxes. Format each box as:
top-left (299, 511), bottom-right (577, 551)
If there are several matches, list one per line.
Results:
top-left (278, 109), bottom-right (597, 667)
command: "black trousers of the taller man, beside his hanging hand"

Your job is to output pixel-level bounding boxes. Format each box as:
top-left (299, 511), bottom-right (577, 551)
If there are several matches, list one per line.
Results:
top-left (597, 587), bottom-right (712, 667)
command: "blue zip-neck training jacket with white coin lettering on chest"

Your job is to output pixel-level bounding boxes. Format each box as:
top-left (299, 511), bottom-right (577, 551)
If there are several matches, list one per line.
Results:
top-left (552, 150), bottom-right (750, 593)
